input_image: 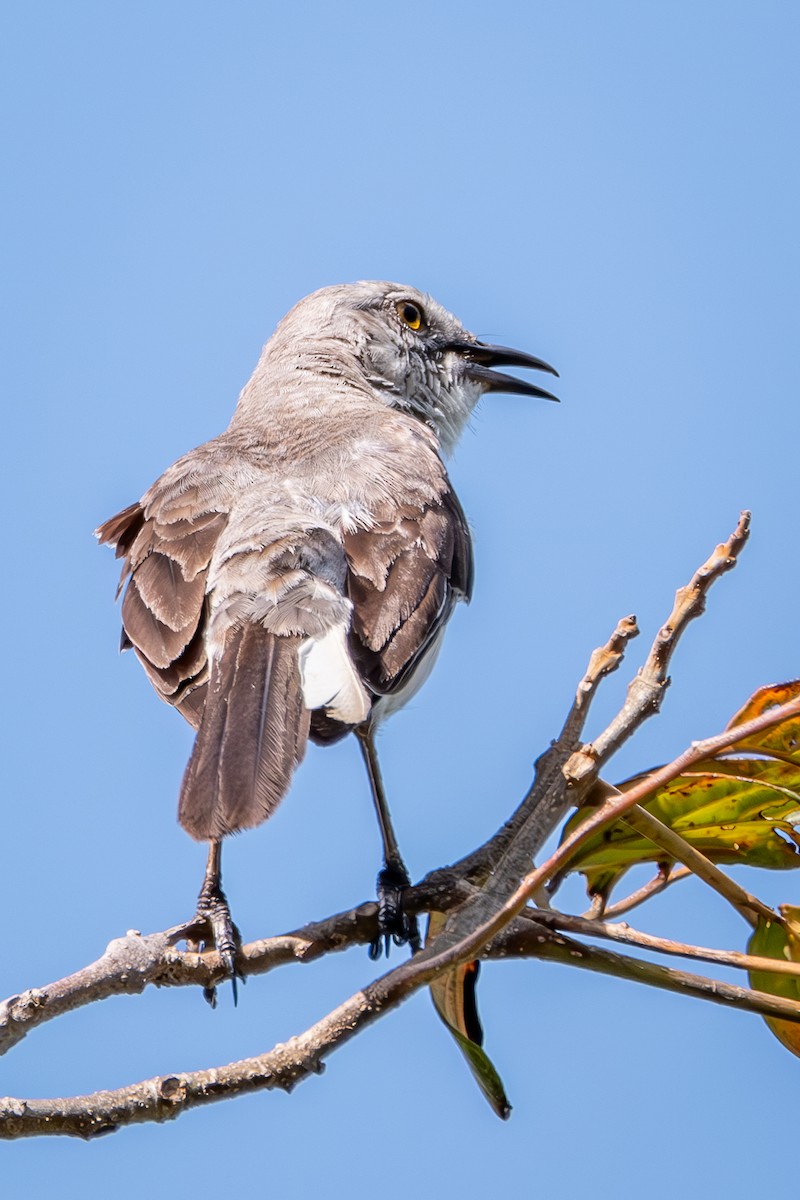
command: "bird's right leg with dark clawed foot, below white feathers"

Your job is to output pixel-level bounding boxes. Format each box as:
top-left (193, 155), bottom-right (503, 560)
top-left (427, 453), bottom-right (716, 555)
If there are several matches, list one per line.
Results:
top-left (355, 721), bottom-right (422, 959)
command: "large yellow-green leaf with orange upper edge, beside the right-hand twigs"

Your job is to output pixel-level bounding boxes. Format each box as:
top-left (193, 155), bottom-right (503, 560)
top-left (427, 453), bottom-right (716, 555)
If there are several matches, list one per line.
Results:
top-left (561, 680), bottom-right (800, 896)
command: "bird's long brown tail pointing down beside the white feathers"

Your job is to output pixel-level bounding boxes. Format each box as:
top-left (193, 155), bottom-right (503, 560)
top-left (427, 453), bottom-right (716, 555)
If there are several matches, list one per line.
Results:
top-left (178, 624), bottom-right (309, 840)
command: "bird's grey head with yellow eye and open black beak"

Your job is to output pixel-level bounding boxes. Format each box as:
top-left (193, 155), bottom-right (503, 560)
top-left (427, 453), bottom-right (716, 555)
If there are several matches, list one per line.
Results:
top-left (256, 281), bottom-right (558, 450)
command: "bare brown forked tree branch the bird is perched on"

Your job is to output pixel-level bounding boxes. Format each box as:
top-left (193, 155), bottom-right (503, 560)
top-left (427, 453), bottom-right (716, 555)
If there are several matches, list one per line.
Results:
top-left (0, 514), bottom-right (800, 1138)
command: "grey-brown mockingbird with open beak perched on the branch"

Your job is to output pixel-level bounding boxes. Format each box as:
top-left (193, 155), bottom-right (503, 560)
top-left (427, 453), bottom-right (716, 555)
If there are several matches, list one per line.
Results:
top-left (97, 282), bottom-right (557, 983)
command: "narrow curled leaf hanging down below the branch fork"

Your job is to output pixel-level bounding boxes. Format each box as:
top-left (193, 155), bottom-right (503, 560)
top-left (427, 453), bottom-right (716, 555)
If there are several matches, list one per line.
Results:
top-left (427, 912), bottom-right (511, 1121)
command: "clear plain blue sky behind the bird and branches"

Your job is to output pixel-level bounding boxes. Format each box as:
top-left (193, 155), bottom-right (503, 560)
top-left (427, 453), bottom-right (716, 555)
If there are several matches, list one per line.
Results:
top-left (0, 0), bottom-right (800, 1200)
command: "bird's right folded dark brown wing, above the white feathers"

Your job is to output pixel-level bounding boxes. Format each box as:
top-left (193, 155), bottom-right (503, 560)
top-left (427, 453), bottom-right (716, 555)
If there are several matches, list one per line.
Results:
top-left (344, 488), bottom-right (473, 695)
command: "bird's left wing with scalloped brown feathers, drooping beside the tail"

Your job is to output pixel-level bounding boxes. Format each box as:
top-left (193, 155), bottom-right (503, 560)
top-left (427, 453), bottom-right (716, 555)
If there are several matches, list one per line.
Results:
top-left (97, 497), bottom-right (228, 728)
